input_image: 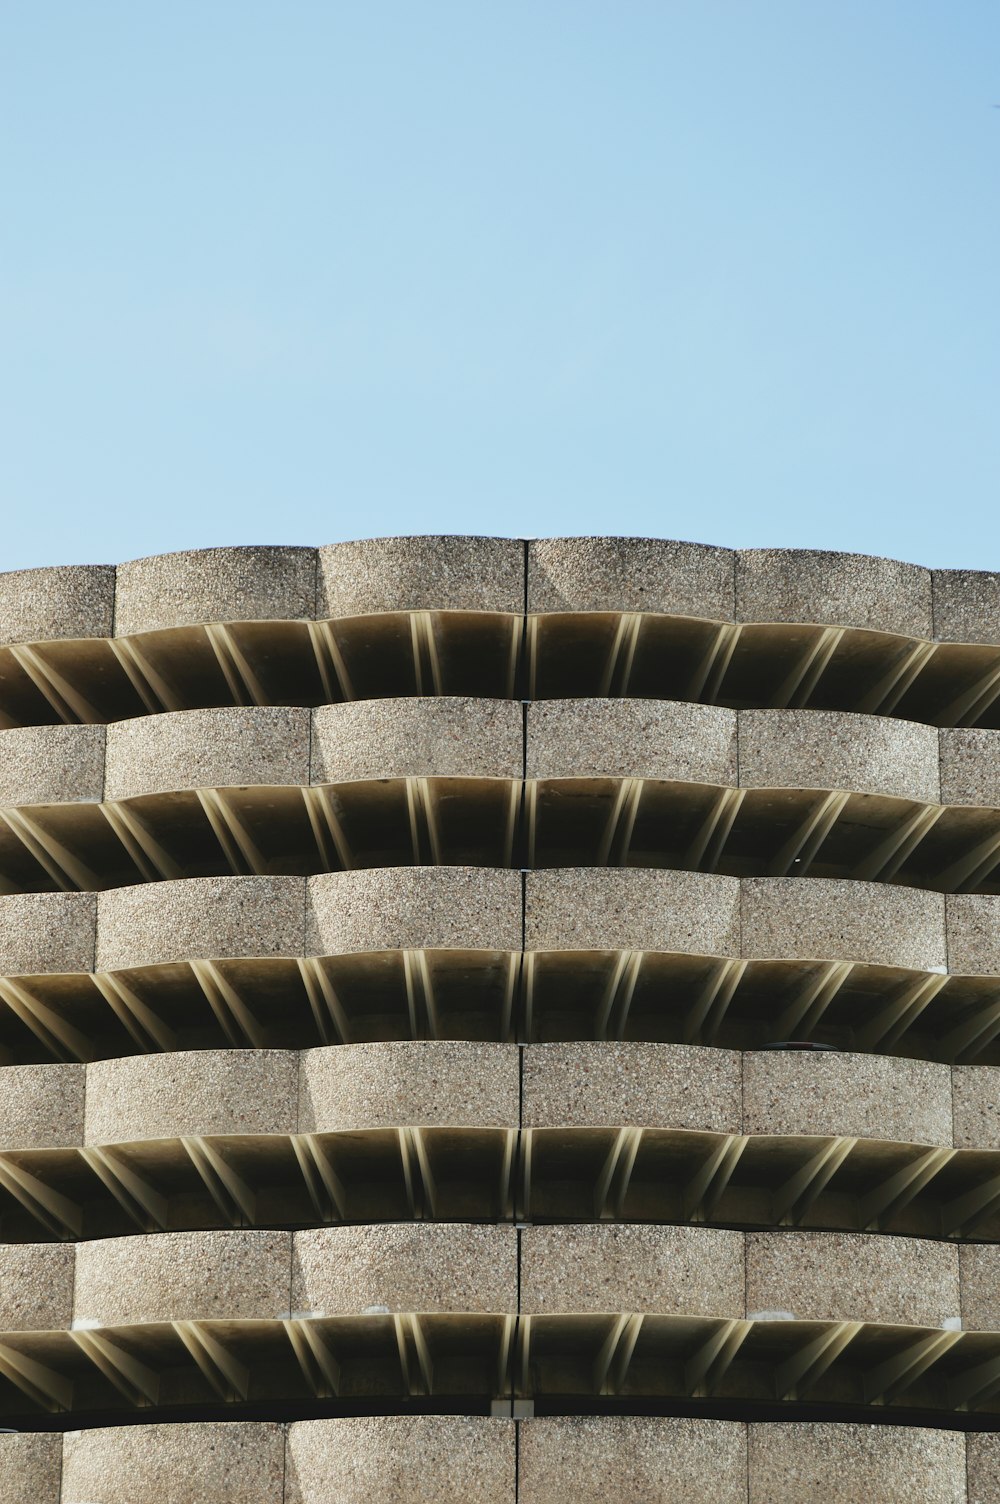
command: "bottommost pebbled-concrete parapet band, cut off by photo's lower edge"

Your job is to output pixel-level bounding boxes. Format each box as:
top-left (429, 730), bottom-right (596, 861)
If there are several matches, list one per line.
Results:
top-left (33, 1415), bottom-right (1000, 1504)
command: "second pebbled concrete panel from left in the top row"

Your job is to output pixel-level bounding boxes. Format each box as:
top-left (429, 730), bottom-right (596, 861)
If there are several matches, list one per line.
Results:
top-left (114, 547), bottom-right (316, 636)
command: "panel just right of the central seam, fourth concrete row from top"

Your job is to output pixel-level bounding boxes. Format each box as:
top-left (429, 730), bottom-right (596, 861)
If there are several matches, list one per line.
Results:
top-left (523, 1042), bottom-right (740, 1133)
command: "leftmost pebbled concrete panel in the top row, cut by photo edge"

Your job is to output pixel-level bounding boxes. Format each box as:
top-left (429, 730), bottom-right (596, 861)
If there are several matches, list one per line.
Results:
top-left (0, 564), bottom-right (114, 642)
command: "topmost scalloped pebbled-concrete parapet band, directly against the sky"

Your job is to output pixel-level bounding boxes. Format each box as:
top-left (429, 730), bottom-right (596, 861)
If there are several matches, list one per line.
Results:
top-left (0, 535), bottom-right (1000, 642)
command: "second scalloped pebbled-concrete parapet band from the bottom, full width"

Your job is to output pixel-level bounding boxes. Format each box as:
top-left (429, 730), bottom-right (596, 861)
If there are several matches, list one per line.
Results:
top-left (0, 1221), bottom-right (1000, 1333)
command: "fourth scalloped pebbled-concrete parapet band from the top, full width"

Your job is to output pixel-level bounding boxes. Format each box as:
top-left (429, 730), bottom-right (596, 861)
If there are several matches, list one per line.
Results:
top-left (0, 1039), bottom-right (1000, 1151)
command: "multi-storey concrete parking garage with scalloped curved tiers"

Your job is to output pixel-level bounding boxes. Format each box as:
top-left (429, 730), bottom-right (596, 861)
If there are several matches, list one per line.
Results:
top-left (0, 538), bottom-right (1000, 1504)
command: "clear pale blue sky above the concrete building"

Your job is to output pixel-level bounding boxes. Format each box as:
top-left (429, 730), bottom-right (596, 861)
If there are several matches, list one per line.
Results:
top-left (0, 0), bottom-right (1000, 569)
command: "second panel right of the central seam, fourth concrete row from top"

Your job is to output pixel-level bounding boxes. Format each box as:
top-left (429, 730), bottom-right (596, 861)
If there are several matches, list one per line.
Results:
top-left (743, 1050), bottom-right (952, 1148)
